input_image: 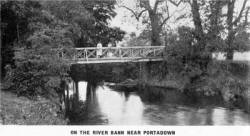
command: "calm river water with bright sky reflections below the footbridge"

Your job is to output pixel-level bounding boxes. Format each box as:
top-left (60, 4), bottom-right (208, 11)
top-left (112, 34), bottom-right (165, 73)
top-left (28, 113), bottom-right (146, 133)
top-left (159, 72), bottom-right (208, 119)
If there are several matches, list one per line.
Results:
top-left (67, 82), bottom-right (250, 125)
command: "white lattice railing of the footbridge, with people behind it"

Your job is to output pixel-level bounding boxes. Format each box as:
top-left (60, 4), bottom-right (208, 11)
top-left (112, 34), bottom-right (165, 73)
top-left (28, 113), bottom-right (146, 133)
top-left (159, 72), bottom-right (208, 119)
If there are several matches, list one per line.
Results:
top-left (74, 46), bottom-right (165, 61)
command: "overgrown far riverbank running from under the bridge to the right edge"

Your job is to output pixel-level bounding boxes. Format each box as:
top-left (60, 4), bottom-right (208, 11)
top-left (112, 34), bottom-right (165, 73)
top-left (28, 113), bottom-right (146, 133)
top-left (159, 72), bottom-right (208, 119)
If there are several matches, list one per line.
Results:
top-left (69, 60), bottom-right (250, 104)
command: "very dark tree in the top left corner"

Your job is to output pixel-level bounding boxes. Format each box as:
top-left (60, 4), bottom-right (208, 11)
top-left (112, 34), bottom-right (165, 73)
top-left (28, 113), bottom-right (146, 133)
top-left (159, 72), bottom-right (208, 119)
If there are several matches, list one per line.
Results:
top-left (1, 1), bottom-right (41, 77)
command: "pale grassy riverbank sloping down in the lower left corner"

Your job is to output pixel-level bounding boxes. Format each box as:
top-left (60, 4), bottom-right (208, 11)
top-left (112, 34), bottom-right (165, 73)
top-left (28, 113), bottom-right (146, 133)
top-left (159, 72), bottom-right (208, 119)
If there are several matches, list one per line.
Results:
top-left (0, 90), bottom-right (67, 125)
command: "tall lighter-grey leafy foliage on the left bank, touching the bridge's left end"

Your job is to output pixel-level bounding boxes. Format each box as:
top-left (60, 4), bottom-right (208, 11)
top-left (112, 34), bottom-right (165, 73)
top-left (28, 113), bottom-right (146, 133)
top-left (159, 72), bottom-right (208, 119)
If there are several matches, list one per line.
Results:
top-left (6, 2), bottom-right (73, 98)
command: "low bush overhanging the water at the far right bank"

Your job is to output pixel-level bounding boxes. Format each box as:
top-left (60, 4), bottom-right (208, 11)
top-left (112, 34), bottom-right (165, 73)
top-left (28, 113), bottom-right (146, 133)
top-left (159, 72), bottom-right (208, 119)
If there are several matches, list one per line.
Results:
top-left (188, 61), bottom-right (248, 101)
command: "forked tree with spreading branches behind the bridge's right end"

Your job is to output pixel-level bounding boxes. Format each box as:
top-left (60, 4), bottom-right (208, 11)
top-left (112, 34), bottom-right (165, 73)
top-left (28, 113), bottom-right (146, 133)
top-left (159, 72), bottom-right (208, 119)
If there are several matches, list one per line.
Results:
top-left (117, 0), bottom-right (182, 46)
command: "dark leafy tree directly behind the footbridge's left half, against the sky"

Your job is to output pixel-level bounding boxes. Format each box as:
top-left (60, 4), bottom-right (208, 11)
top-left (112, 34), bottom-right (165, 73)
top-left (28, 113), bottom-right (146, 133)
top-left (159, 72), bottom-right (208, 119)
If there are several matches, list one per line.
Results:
top-left (77, 0), bottom-right (125, 47)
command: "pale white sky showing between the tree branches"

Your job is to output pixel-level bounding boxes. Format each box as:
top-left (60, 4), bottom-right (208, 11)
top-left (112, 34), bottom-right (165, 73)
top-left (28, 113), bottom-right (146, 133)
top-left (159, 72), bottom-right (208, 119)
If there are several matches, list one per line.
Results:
top-left (110, 0), bottom-right (250, 35)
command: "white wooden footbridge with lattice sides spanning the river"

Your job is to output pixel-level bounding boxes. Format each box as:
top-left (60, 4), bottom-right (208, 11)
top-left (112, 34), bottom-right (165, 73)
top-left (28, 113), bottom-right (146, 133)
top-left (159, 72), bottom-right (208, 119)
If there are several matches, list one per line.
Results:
top-left (67, 46), bottom-right (165, 64)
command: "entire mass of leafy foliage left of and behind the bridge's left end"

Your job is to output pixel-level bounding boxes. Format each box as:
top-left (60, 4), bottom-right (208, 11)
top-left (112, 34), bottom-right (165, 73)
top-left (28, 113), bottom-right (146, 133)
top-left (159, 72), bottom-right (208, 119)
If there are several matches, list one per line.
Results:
top-left (1, 0), bottom-right (125, 98)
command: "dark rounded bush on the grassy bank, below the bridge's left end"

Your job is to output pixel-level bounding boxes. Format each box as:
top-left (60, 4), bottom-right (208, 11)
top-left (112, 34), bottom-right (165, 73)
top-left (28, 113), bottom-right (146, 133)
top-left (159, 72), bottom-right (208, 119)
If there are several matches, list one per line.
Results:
top-left (6, 61), bottom-right (67, 98)
